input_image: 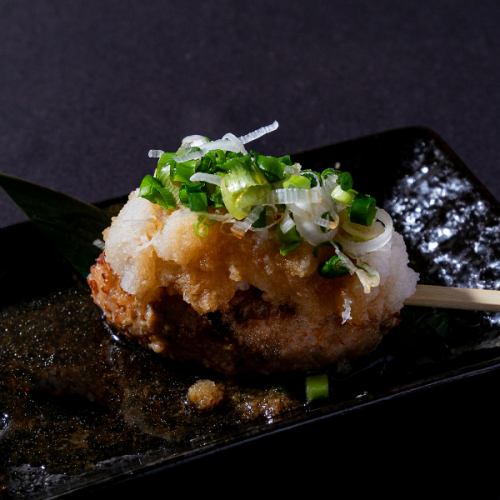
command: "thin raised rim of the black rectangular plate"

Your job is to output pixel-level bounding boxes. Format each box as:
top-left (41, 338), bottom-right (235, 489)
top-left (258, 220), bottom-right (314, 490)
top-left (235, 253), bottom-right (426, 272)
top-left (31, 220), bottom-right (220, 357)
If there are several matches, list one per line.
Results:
top-left (0, 126), bottom-right (500, 498)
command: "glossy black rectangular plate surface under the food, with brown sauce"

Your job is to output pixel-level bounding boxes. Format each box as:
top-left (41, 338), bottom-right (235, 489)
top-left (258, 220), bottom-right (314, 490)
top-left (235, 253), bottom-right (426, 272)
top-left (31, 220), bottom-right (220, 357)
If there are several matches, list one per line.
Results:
top-left (0, 128), bottom-right (500, 496)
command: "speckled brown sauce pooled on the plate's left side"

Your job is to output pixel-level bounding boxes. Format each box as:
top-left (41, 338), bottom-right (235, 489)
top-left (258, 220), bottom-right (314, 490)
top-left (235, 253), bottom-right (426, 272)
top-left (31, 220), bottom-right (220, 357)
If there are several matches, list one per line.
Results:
top-left (0, 284), bottom-right (296, 494)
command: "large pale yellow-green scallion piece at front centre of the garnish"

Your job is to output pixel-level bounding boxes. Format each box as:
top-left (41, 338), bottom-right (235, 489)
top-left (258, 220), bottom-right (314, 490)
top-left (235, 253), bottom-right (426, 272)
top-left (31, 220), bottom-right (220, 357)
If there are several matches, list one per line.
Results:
top-left (220, 157), bottom-right (271, 220)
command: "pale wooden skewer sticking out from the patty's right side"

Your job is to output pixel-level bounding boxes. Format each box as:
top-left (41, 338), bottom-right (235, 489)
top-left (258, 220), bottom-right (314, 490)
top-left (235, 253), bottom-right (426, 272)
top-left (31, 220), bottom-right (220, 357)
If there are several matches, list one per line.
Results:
top-left (405, 285), bottom-right (500, 311)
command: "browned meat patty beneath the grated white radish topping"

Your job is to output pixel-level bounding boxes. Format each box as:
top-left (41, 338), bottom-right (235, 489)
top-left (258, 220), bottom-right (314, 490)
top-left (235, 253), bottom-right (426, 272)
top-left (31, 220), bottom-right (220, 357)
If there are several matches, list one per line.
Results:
top-left (88, 254), bottom-right (398, 374)
